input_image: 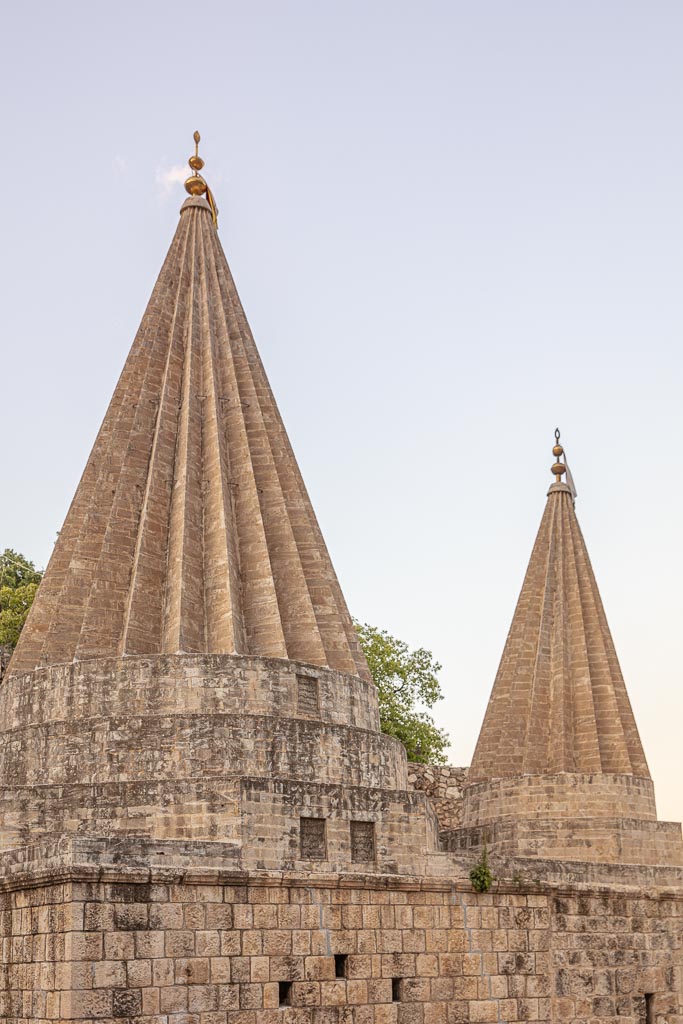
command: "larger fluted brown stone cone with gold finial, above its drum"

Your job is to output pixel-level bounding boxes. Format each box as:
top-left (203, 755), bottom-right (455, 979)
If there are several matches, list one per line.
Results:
top-left (9, 136), bottom-right (370, 679)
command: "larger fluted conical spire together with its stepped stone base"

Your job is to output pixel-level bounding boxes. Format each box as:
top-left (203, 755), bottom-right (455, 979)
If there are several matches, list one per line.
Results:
top-left (0, 137), bottom-right (450, 872)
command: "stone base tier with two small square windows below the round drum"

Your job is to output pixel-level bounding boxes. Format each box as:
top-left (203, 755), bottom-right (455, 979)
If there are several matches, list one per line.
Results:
top-left (0, 776), bottom-right (446, 874)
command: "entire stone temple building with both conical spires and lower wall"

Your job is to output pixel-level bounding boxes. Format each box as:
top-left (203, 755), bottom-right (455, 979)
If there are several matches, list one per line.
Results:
top-left (0, 138), bottom-right (683, 1024)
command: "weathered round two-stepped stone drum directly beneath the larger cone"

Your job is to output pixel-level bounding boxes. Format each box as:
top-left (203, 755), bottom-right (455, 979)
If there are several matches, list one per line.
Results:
top-left (0, 655), bottom-right (393, 788)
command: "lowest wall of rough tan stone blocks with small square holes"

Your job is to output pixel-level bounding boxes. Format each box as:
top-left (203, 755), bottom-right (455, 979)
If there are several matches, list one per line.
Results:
top-left (0, 866), bottom-right (683, 1024)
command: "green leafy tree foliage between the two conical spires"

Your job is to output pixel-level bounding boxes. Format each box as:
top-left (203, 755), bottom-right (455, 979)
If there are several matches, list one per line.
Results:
top-left (354, 622), bottom-right (449, 765)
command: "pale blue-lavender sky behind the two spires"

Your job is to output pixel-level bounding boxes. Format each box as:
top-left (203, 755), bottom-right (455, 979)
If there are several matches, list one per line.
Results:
top-left (0, 0), bottom-right (683, 820)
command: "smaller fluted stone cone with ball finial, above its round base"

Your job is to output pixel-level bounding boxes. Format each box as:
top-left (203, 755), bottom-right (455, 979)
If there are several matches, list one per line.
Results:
top-left (469, 434), bottom-right (649, 782)
